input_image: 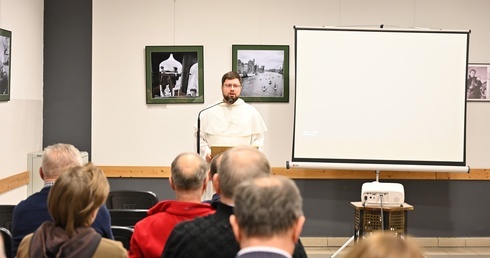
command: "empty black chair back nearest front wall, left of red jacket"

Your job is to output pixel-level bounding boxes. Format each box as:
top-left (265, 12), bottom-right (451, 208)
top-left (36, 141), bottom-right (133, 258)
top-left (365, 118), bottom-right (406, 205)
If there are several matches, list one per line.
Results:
top-left (106, 190), bottom-right (158, 209)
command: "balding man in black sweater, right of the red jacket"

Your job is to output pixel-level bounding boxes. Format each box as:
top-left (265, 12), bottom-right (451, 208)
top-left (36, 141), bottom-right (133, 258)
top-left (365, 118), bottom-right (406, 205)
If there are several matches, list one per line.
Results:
top-left (162, 146), bottom-right (306, 258)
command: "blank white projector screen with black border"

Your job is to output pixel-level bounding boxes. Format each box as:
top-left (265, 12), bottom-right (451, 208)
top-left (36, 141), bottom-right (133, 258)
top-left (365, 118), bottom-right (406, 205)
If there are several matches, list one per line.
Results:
top-left (292, 27), bottom-right (469, 171)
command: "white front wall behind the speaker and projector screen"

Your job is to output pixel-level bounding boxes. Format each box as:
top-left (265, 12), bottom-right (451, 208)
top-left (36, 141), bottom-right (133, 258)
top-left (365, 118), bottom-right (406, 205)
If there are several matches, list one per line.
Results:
top-left (92, 0), bottom-right (490, 168)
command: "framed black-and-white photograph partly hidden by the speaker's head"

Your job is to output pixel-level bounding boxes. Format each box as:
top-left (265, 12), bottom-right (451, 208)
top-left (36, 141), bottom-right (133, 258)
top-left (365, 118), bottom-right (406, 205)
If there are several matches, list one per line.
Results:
top-left (232, 45), bottom-right (289, 102)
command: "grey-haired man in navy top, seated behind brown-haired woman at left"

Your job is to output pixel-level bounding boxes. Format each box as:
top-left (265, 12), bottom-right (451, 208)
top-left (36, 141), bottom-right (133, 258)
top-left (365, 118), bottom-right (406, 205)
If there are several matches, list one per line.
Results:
top-left (12, 143), bottom-right (114, 257)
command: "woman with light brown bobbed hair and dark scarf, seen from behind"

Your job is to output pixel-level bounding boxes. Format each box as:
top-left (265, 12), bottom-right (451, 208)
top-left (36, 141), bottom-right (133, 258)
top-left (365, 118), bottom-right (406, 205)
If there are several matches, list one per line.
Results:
top-left (17, 163), bottom-right (127, 258)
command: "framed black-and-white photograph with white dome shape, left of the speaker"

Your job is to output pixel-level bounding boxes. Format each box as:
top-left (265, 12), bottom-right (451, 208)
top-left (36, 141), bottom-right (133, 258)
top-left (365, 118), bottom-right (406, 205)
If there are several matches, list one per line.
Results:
top-left (145, 46), bottom-right (204, 104)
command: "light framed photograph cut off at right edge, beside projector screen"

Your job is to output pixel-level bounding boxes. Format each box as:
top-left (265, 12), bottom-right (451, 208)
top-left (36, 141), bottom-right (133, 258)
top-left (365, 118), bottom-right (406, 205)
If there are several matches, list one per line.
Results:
top-left (466, 64), bottom-right (490, 101)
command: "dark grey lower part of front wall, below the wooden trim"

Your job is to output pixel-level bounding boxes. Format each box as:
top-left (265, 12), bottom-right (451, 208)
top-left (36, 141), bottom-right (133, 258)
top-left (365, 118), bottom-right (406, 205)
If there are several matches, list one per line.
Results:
top-left (109, 178), bottom-right (490, 237)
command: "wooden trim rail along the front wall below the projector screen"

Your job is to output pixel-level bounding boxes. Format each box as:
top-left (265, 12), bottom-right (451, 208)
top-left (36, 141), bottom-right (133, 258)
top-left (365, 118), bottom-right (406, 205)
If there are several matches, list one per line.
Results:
top-left (99, 166), bottom-right (490, 180)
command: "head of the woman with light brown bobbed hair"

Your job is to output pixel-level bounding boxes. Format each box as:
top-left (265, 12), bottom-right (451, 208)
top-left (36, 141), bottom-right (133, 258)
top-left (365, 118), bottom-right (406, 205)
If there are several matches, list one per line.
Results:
top-left (48, 163), bottom-right (109, 237)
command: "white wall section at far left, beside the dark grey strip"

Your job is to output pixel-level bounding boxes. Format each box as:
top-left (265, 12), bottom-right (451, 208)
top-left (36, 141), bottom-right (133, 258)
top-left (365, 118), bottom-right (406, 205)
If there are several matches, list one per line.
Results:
top-left (0, 0), bottom-right (43, 204)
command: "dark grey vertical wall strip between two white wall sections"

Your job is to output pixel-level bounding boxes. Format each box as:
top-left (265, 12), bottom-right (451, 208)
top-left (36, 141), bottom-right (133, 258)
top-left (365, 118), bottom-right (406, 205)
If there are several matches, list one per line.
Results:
top-left (43, 0), bottom-right (92, 155)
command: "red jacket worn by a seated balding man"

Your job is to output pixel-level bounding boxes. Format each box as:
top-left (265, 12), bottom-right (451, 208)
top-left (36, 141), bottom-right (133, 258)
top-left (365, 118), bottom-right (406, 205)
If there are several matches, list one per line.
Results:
top-left (128, 201), bottom-right (215, 258)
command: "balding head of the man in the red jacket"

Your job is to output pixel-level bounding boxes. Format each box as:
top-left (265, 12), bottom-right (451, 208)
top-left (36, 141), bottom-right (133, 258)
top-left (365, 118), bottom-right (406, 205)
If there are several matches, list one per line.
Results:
top-left (170, 152), bottom-right (208, 191)
